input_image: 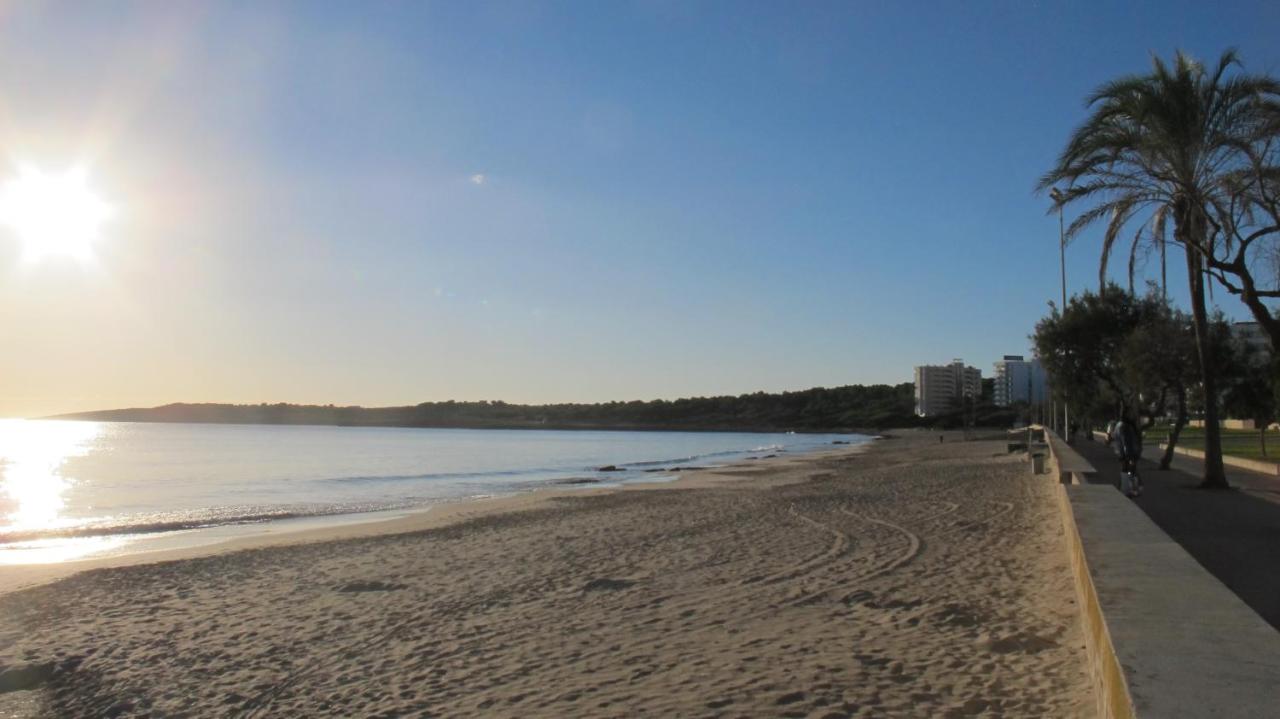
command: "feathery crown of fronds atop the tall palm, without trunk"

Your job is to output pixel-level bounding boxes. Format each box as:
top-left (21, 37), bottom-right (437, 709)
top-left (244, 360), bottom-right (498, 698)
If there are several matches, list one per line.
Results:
top-left (1036, 49), bottom-right (1280, 301)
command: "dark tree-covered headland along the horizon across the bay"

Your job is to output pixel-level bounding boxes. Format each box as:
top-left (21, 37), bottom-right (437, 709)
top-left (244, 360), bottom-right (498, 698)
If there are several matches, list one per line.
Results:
top-left (49, 383), bottom-right (988, 432)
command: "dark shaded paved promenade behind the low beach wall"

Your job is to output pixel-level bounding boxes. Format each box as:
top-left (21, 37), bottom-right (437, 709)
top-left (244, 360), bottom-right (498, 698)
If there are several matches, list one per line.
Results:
top-left (1071, 436), bottom-right (1280, 629)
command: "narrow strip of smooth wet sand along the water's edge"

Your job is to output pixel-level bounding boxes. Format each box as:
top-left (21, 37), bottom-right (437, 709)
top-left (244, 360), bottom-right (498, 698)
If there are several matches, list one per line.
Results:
top-left (0, 435), bottom-right (877, 596)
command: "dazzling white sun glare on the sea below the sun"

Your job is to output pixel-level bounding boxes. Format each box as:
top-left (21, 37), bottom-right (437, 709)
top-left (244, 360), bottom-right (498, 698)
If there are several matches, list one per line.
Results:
top-left (0, 420), bottom-right (102, 536)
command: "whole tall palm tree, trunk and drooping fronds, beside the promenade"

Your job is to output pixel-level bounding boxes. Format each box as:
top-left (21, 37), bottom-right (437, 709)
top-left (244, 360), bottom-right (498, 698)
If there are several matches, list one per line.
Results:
top-left (1037, 50), bottom-right (1274, 487)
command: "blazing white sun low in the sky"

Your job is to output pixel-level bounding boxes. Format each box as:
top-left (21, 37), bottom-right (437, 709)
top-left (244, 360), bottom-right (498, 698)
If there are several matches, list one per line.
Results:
top-left (0, 168), bottom-right (111, 261)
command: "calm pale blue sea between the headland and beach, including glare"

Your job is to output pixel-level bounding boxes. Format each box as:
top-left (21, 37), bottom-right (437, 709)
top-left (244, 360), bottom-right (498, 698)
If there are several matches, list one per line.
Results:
top-left (0, 420), bottom-right (869, 564)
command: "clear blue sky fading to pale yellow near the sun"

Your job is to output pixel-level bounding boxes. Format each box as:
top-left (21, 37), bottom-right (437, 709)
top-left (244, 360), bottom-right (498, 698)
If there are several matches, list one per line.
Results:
top-left (0, 1), bottom-right (1280, 415)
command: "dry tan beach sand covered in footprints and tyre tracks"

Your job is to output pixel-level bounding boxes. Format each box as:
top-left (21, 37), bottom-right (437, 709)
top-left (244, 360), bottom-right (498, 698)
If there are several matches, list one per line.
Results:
top-left (0, 432), bottom-right (1093, 718)
